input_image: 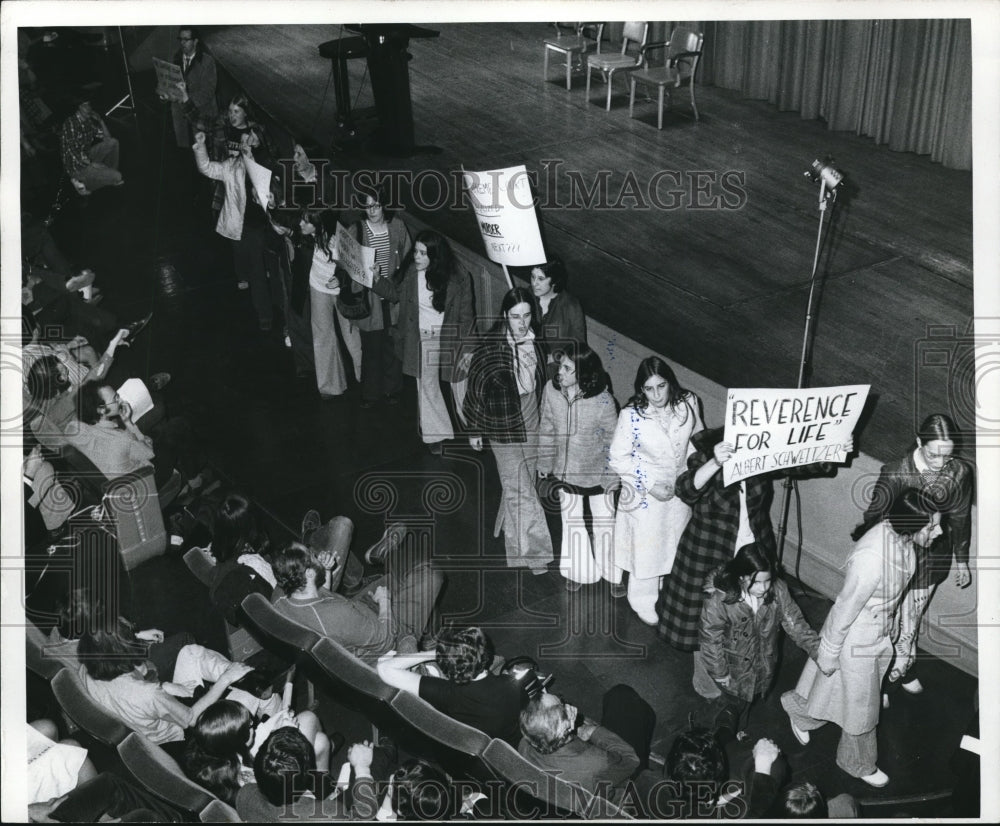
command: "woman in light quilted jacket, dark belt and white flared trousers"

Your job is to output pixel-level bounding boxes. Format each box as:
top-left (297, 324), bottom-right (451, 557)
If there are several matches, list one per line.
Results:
top-left (538, 342), bottom-right (618, 591)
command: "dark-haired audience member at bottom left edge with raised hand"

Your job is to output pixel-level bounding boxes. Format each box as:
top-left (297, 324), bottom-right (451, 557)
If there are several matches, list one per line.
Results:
top-left (236, 726), bottom-right (378, 823)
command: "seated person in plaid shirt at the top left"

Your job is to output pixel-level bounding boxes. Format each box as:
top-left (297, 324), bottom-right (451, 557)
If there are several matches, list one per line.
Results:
top-left (59, 91), bottom-right (124, 195)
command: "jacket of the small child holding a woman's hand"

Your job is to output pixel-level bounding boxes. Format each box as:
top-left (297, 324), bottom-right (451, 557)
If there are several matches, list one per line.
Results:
top-left (696, 569), bottom-right (819, 701)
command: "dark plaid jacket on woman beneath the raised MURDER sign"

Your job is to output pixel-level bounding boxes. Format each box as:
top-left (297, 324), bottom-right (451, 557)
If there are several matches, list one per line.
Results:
top-left (463, 320), bottom-right (546, 444)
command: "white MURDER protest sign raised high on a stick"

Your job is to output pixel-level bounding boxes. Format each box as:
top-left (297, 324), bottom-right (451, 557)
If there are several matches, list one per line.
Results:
top-left (462, 164), bottom-right (545, 267)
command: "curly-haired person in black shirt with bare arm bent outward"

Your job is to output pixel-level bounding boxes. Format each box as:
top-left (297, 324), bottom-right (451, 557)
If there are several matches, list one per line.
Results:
top-left (378, 628), bottom-right (526, 747)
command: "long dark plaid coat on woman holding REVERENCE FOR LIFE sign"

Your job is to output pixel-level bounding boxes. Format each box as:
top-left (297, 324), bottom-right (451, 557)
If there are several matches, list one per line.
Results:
top-left (656, 443), bottom-right (776, 651)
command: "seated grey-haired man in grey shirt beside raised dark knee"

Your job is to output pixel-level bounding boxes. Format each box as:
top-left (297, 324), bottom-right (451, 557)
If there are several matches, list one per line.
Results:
top-left (517, 685), bottom-right (656, 802)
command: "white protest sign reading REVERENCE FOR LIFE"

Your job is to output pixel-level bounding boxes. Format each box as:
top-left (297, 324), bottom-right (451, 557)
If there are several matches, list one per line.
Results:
top-left (722, 384), bottom-right (871, 485)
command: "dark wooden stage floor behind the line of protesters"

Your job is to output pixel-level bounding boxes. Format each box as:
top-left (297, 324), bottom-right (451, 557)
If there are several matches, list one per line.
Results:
top-left (206, 23), bottom-right (973, 459)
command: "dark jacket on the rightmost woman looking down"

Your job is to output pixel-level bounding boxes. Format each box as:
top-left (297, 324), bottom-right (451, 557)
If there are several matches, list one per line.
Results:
top-left (852, 452), bottom-right (974, 588)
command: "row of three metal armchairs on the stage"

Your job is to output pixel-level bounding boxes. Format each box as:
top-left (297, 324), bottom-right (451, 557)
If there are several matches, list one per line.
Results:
top-left (542, 21), bottom-right (705, 129)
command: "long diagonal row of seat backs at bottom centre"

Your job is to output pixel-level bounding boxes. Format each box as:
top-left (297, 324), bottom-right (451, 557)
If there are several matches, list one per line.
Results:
top-left (242, 594), bottom-right (628, 819)
